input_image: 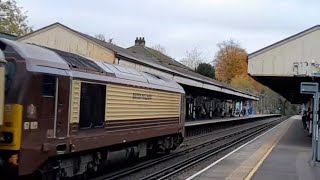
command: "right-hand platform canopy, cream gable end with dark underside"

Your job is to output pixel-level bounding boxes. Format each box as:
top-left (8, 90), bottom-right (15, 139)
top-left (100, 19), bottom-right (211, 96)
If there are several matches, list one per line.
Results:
top-left (248, 25), bottom-right (320, 103)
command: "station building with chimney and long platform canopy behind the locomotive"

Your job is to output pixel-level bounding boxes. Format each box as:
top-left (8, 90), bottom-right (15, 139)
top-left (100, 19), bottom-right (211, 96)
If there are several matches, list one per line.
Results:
top-left (17, 23), bottom-right (259, 120)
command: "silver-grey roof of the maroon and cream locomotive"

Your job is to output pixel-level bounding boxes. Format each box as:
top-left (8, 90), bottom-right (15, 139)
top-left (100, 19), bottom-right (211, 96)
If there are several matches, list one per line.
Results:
top-left (0, 38), bottom-right (184, 93)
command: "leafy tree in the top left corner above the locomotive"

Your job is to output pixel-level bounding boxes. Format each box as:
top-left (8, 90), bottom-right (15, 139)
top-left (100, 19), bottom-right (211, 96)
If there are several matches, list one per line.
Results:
top-left (0, 0), bottom-right (32, 36)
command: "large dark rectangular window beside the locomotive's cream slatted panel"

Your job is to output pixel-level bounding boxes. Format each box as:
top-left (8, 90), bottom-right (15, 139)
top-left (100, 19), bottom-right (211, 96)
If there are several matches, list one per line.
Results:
top-left (79, 83), bottom-right (106, 129)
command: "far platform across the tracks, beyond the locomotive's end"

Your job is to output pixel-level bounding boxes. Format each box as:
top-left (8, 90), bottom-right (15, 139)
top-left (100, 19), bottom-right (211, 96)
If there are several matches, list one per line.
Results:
top-left (185, 114), bottom-right (281, 127)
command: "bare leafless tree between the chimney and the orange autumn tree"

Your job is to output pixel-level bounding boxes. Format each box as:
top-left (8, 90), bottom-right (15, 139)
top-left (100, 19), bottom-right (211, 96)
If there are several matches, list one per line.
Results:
top-left (180, 47), bottom-right (204, 70)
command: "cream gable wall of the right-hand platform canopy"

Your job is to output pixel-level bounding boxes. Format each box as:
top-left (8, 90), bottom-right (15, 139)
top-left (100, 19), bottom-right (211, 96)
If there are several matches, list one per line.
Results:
top-left (248, 29), bottom-right (320, 76)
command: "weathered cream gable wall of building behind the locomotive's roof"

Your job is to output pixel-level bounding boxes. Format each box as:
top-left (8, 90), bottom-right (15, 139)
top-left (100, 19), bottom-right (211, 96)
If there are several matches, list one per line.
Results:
top-left (18, 25), bottom-right (115, 63)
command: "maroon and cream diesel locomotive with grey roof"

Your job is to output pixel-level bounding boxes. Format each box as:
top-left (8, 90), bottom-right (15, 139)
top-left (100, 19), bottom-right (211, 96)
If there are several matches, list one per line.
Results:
top-left (0, 39), bottom-right (185, 179)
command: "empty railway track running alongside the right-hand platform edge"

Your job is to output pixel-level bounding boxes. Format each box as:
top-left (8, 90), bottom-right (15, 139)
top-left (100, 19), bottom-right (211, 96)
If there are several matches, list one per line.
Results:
top-left (95, 117), bottom-right (287, 180)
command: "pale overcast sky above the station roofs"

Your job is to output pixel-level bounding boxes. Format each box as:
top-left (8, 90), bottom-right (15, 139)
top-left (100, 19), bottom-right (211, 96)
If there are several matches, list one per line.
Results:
top-left (17, 0), bottom-right (320, 61)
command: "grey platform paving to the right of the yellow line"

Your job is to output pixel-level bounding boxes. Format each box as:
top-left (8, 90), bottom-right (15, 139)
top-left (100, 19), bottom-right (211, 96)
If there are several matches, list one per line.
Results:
top-left (251, 115), bottom-right (320, 180)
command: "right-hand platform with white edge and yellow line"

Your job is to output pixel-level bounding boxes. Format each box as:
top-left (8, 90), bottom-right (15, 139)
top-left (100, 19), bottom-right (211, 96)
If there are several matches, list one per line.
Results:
top-left (187, 116), bottom-right (320, 180)
